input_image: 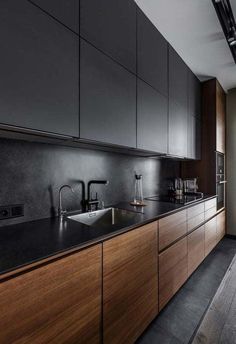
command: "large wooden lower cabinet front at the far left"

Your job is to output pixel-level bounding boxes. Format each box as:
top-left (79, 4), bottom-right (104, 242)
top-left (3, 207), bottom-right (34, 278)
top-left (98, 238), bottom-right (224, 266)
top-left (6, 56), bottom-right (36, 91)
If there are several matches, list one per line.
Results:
top-left (0, 245), bottom-right (102, 344)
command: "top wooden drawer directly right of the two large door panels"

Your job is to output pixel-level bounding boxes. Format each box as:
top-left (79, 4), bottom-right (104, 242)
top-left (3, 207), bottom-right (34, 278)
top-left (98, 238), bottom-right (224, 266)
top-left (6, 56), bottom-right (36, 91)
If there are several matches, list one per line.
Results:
top-left (159, 210), bottom-right (187, 251)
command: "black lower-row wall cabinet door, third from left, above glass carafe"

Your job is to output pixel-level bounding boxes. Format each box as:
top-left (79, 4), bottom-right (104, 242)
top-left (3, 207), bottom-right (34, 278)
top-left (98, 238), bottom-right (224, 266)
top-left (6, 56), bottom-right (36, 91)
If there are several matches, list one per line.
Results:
top-left (137, 80), bottom-right (168, 153)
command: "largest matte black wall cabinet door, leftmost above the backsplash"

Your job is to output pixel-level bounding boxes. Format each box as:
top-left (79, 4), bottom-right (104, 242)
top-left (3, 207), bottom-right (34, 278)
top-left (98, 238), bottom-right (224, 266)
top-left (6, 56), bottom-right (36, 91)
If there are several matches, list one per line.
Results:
top-left (0, 0), bottom-right (79, 136)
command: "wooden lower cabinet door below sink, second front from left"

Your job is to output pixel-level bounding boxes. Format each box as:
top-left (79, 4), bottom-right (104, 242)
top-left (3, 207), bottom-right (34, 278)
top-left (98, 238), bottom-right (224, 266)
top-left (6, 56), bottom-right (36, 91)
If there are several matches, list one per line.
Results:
top-left (103, 222), bottom-right (158, 344)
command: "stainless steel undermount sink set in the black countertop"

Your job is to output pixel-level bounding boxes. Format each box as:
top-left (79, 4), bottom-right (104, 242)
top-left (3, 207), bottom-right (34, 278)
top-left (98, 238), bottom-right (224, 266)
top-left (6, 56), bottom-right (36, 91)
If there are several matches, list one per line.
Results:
top-left (68, 208), bottom-right (137, 227)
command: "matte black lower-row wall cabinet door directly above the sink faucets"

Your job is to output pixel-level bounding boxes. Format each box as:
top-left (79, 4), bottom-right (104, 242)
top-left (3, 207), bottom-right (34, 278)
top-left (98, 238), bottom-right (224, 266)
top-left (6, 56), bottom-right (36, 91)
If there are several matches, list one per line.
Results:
top-left (80, 39), bottom-right (136, 147)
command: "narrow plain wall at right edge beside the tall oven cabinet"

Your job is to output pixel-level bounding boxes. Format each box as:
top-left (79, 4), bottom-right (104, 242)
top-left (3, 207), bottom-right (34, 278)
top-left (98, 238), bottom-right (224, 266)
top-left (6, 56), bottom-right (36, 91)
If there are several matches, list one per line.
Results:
top-left (226, 88), bottom-right (236, 235)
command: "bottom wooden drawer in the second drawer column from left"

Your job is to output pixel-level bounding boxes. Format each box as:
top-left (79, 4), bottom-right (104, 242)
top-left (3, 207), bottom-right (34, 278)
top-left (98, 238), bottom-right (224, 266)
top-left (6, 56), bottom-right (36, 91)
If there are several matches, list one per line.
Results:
top-left (188, 226), bottom-right (205, 276)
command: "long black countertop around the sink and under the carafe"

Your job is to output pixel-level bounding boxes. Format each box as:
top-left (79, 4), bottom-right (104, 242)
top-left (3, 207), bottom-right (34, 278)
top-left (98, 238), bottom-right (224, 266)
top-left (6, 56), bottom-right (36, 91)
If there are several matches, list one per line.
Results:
top-left (0, 196), bottom-right (216, 276)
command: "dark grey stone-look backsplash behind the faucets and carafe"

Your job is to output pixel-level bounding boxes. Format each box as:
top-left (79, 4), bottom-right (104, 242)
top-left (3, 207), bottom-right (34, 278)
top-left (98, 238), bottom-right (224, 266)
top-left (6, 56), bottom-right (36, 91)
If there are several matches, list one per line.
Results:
top-left (0, 139), bottom-right (180, 227)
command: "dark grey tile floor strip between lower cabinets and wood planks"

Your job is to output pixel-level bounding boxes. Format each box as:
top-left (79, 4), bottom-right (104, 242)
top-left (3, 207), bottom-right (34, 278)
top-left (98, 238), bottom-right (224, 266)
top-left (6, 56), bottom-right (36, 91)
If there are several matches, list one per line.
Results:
top-left (137, 238), bottom-right (236, 344)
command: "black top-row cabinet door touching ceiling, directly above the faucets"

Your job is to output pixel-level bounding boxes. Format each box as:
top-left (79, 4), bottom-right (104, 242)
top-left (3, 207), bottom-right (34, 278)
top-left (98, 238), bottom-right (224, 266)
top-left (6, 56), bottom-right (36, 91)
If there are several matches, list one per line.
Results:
top-left (80, 0), bottom-right (136, 73)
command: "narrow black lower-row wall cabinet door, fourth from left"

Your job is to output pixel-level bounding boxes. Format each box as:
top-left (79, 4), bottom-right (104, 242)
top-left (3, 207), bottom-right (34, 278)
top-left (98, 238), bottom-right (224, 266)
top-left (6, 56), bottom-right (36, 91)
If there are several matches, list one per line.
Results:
top-left (169, 100), bottom-right (188, 157)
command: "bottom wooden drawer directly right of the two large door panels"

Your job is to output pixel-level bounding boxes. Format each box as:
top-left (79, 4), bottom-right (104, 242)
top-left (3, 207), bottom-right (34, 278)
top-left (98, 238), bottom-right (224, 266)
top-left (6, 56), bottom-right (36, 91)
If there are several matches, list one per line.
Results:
top-left (159, 237), bottom-right (188, 310)
